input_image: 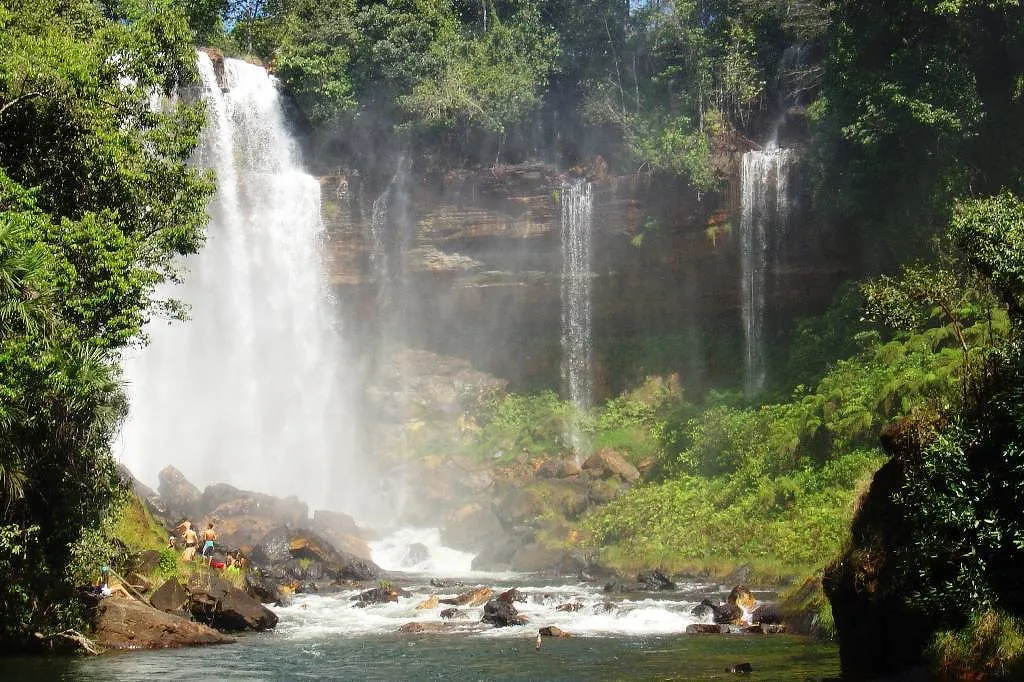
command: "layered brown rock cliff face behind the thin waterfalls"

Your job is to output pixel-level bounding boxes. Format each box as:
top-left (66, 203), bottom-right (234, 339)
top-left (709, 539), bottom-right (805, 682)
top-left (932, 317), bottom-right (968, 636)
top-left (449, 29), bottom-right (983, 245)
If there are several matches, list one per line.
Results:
top-left (322, 157), bottom-right (851, 400)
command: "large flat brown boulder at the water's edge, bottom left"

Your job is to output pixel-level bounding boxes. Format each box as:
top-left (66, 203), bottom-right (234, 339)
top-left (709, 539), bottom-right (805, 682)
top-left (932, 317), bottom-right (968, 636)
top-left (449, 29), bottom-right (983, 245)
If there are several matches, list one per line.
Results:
top-left (95, 597), bottom-right (234, 649)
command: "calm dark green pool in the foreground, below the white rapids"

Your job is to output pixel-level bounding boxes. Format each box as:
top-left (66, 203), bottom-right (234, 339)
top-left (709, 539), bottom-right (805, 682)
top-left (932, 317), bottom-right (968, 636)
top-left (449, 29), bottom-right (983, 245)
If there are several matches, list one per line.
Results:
top-left (0, 629), bottom-right (839, 681)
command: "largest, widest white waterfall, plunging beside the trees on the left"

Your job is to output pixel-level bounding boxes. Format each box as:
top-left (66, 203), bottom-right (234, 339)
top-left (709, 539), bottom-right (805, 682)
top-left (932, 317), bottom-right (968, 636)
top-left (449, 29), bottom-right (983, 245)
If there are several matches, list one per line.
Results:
top-left (122, 53), bottom-right (359, 510)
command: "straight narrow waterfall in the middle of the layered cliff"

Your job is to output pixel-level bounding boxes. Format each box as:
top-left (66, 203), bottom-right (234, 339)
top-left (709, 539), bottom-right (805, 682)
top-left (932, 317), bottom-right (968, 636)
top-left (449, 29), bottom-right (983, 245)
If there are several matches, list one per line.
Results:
top-left (561, 178), bottom-right (593, 464)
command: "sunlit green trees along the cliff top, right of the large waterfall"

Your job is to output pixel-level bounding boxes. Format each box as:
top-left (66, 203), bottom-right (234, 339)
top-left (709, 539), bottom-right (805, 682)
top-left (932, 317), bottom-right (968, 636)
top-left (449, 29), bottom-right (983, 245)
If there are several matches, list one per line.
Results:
top-left (211, 0), bottom-right (815, 183)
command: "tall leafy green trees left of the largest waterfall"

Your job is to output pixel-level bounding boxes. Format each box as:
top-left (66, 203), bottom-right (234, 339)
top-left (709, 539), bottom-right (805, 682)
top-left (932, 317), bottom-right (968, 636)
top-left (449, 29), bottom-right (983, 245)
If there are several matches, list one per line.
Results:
top-left (0, 0), bottom-right (211, 648)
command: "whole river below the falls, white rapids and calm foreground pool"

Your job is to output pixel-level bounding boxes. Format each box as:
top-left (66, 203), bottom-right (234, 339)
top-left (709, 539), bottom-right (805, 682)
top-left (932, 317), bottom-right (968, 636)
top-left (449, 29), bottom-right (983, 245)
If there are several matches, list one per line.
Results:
top-left (0, 531), bottom-right (839, 681)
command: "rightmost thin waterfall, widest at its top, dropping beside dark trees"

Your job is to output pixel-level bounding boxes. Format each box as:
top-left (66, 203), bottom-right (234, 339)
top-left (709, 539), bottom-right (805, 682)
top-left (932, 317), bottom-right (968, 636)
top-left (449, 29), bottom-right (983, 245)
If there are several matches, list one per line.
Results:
top-left (739, 142), bottom-right (793, 395)
